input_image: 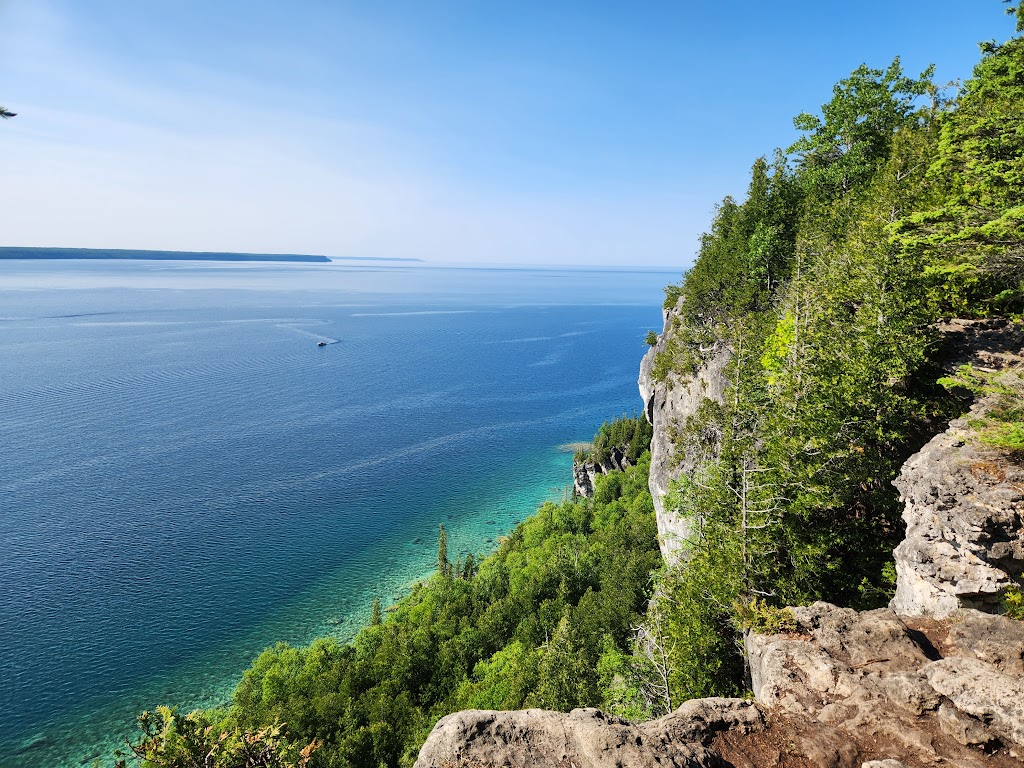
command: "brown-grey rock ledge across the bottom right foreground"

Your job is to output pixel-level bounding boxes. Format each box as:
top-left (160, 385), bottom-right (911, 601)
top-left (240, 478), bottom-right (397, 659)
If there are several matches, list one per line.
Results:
top-left (416, 602), bottom-right (1024, 768)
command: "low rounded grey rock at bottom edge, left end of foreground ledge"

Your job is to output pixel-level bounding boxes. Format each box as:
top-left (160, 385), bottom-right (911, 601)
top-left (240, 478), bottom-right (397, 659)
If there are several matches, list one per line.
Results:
top-left (415, 698), bottom-right (765, 768)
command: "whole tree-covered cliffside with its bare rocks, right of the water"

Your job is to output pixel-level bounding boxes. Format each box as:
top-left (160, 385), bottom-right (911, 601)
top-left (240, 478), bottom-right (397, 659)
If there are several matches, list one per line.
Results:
top-left (116, 6), bottom-right (1024, 768)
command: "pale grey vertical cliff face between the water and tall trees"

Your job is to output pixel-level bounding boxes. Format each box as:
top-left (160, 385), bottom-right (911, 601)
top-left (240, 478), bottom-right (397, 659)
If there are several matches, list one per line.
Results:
top-left (637, 306), bottom-right (731, 562)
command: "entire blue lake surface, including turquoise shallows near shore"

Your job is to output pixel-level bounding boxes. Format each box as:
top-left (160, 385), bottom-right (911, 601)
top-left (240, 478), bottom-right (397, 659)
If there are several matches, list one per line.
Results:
top-left (0, 261), bottom-right (678, 767)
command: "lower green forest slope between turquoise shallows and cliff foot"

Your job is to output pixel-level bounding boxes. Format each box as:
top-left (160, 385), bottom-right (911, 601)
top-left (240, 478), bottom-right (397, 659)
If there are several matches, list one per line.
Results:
top-left (128, 454), bottom-right (659, 768)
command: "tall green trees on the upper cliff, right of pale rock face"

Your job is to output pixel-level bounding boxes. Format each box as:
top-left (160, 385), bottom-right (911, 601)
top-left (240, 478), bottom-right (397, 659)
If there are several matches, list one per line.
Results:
top-left (643, 13), bottom-right (1024, 712)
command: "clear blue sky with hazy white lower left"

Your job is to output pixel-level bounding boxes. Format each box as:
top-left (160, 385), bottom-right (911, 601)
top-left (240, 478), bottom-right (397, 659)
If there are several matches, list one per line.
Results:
top-left (0, 0), bottom-right (1013, 269)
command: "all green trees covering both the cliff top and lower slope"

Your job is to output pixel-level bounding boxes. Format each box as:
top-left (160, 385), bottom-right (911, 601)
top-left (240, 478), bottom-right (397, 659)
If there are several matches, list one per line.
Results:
top-left (123, 9), bottom-right (1024, 768)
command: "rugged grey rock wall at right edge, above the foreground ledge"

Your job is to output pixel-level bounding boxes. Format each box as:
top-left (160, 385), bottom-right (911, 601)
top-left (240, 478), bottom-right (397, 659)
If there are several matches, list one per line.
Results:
top-left (891, 321), bottom-right (1024, 617)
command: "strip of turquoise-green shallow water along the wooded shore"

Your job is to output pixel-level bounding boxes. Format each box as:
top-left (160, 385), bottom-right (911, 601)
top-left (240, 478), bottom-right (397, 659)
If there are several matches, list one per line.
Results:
top-left (0, 446), bottom-right (571, 768)
